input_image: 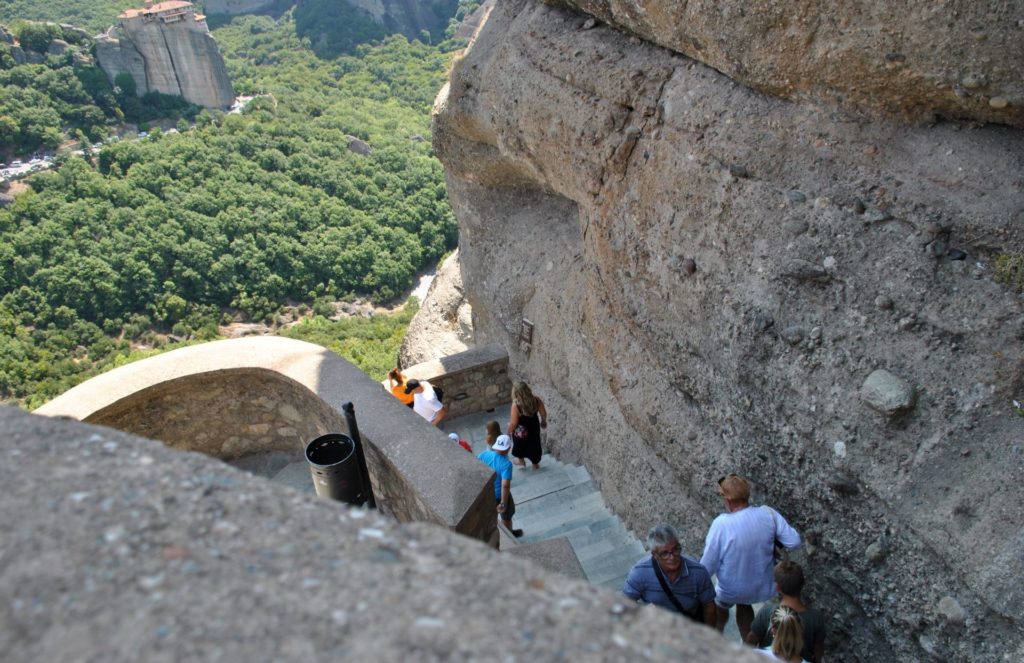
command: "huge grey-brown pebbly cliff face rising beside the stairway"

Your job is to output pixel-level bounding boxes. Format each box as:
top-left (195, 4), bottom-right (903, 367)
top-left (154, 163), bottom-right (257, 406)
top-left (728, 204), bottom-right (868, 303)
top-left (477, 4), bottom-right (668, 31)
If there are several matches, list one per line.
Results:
top-left (434, 0), bottom-right (1024, 661)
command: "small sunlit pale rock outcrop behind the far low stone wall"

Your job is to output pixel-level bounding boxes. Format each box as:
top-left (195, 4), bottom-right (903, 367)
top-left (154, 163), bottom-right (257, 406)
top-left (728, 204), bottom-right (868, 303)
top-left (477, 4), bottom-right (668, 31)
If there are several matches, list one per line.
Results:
top-left (398, 251), bottom-right (473, 366)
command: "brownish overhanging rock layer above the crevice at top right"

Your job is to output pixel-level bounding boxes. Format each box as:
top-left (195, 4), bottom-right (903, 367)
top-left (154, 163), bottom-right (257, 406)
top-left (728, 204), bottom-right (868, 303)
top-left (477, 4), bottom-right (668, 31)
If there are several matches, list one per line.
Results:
top-left (547, 0), bottom-right (1024, 126)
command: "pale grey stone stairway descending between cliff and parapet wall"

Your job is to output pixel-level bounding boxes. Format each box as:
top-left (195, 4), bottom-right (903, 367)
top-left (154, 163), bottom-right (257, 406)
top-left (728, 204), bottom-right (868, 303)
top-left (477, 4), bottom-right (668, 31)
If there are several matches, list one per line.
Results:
top-left (443, 406), bottom-right (644, 591)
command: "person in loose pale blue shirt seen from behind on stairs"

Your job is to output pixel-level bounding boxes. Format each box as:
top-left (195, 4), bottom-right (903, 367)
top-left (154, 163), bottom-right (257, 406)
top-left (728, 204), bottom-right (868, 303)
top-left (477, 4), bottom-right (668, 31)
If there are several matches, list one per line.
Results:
top-left (700, 474), bottom-right (801, 641)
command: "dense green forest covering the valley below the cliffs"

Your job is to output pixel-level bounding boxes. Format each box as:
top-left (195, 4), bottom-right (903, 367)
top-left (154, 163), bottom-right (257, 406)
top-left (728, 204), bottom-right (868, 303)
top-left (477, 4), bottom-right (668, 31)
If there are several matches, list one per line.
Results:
top-left (0, 0), bottom-right (475, 408)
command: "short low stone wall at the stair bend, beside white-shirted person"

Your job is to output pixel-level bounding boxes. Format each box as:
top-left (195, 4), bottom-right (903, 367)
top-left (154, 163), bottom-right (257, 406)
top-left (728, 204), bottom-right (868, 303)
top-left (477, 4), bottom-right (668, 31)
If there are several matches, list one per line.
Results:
top-left (402, 343), bottom-right (512, 417)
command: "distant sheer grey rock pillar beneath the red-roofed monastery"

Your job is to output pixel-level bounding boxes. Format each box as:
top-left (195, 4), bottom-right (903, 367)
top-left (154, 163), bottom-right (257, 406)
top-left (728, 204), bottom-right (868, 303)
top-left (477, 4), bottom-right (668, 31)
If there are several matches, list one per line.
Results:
top-left (96, 9), bottom-right (234, 109)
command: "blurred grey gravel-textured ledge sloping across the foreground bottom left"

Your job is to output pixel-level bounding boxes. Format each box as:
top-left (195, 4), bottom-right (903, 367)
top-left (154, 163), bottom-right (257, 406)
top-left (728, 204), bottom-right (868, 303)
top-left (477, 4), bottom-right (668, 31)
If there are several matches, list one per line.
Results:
top-left (0, 407), bottom-right (763, 663)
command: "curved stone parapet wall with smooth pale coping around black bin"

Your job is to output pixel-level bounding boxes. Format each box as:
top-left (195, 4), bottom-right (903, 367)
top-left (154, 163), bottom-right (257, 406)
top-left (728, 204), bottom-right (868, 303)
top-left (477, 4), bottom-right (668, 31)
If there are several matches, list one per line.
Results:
top-left (37, 336), bottom-right (497, 541)
